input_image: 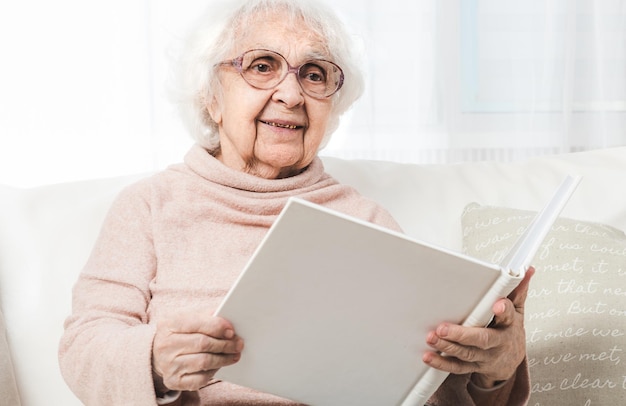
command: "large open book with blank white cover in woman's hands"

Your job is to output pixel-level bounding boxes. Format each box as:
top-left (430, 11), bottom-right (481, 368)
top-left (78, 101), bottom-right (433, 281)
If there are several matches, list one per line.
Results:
top-left (216, 177), bottom-right (580, 406)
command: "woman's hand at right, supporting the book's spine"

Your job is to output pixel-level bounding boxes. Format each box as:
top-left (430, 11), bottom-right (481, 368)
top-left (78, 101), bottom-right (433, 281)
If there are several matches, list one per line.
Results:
top-left (423, 268), bottom-right (534, 388)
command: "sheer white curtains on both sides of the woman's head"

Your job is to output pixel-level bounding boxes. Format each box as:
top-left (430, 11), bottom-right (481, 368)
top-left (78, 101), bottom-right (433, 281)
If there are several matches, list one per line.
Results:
top-left (0, 0), bottom-right (626, 186)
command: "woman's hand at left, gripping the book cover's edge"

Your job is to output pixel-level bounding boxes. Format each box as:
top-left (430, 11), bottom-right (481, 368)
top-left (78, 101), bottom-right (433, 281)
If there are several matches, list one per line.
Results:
top-left (152, 311), bottom-right (243, 393)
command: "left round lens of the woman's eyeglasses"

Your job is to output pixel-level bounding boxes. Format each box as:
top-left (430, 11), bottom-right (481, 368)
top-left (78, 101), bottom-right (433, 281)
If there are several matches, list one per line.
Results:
top-left (241, 50), bottom-right (288, 89)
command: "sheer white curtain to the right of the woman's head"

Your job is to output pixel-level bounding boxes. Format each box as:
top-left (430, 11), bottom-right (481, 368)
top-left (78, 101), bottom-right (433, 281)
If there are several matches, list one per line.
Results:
top-left (326, 0), bottom-right (626, 162)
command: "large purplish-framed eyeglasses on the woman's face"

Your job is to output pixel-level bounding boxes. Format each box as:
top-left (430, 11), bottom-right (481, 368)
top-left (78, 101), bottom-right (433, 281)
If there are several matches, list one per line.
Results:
top-left (219, 49), bottom-right (343, 99)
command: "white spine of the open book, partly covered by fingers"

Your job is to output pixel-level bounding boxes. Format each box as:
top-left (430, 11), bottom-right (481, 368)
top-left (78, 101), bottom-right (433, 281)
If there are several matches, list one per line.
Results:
top-left (402, 271), bottom-right (524, 406)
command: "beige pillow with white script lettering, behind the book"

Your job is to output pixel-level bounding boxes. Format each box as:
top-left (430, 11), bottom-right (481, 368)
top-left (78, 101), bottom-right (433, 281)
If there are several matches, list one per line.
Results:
top-left (462, 203), bottom-right (626, 406)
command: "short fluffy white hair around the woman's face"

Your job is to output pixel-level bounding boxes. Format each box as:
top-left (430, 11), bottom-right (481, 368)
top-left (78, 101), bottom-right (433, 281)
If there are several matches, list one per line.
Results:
top-left (169, 0), bottom-right (364, 151)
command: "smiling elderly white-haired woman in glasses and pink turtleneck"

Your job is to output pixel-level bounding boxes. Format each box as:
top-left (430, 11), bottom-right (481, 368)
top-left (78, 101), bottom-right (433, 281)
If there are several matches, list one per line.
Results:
top-left (59, 0), bottom-right (528, 405)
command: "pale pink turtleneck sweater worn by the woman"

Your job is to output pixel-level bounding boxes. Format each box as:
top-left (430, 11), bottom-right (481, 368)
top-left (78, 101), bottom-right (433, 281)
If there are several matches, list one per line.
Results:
top-left (59, 146), bottom-right (527, 405)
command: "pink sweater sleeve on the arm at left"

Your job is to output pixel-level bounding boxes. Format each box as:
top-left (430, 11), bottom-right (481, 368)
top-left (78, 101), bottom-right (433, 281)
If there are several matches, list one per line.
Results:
top-left (59, 184), bottom-right (161, 405)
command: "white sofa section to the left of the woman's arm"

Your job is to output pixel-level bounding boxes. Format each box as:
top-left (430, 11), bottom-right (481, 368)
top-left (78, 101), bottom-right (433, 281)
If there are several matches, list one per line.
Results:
top-left (0, 175), bottom-right (143, 405)
